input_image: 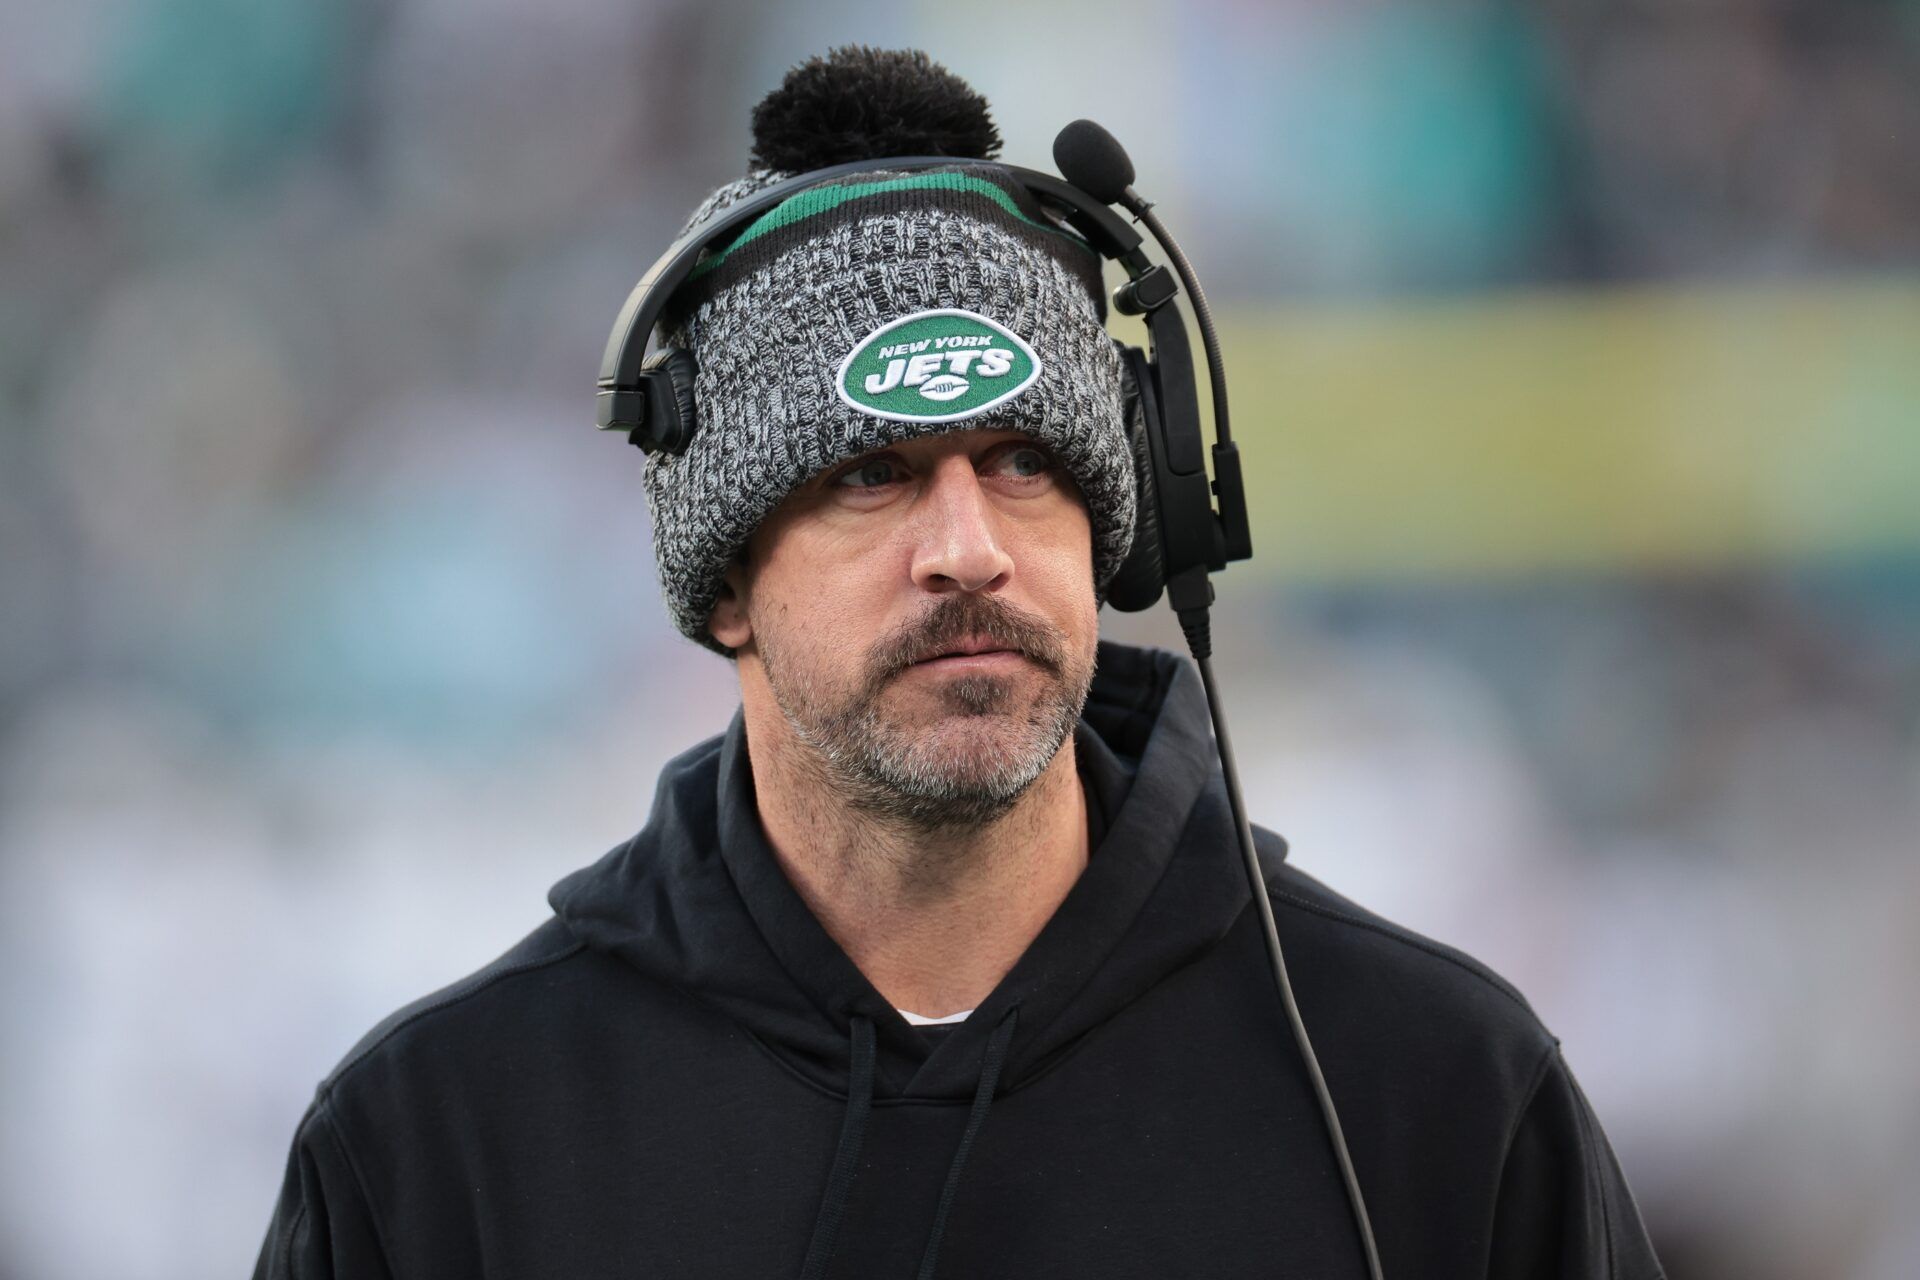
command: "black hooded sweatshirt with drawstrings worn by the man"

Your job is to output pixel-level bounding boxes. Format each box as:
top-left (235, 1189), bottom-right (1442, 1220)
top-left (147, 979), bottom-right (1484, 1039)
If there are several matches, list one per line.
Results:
top-left (255, 643), bottom-right (1661, 1280)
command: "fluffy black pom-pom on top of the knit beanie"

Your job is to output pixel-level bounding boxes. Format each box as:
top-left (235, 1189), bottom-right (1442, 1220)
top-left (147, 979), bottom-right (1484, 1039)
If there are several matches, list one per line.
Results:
top-left (749, 44), bottom-right (1000, 173)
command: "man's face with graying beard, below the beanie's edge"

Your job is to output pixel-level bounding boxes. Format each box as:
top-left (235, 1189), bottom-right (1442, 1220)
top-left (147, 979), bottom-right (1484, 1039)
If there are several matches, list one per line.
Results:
top-left (712, 430), bottom-right (1098, 827)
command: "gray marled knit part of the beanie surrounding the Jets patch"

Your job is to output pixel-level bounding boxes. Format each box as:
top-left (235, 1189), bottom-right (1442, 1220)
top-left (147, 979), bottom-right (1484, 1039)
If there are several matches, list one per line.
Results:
top-left (645, 169), bottom-right (1137, 656)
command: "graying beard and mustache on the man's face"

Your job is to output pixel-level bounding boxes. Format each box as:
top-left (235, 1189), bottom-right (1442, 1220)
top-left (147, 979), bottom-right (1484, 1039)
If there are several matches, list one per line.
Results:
top-left (755, 595), bottom-right (1094, 831)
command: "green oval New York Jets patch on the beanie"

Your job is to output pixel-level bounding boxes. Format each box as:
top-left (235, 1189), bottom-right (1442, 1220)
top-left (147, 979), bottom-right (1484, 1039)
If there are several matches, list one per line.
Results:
top-left (835, 307), bottom-right (1041, 422)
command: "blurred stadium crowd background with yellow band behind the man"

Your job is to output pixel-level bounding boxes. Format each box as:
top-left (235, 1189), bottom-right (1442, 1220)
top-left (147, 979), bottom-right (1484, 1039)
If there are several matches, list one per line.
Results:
top-left (0, 0), bottom-right (1920, 1280)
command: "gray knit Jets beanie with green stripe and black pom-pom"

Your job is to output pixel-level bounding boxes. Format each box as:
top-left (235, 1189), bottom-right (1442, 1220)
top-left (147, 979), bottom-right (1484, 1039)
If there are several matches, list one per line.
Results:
top-left (645, 46), bottom-right (1135, 656)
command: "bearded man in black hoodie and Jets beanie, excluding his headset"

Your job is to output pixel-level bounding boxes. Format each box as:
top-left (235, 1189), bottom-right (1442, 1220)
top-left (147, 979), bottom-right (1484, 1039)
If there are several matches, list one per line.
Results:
top-left (255, 50), bottom-right (1659, 1280)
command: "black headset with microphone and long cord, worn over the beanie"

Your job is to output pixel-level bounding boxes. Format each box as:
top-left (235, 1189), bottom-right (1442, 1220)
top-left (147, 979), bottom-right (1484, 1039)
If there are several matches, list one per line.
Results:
top-left (595, 121), bottom-right (1380, 1280)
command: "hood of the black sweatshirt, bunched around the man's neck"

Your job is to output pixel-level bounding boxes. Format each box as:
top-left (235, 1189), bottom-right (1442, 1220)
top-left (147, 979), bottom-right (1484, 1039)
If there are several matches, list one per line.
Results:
top-left (549, 641), bottom-right (1250, 1100)
